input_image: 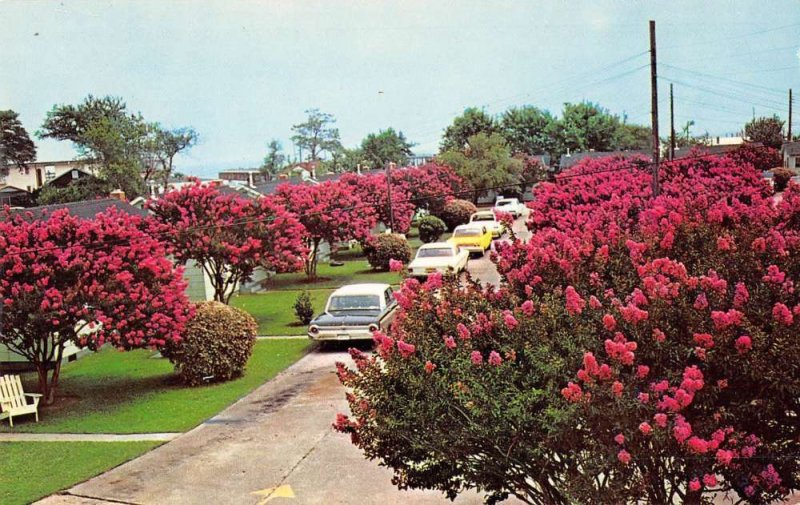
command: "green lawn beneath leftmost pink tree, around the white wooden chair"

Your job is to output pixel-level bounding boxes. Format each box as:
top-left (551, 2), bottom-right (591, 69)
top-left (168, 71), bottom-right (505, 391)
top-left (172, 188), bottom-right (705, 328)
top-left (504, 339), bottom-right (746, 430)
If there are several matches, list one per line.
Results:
top-left (0, 339), bottom-right (310, 433)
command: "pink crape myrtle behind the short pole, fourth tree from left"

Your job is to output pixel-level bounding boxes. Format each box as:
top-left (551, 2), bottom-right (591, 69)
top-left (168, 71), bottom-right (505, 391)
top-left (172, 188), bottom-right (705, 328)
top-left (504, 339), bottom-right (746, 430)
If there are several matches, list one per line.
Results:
top-left (338, 171), bottom-right (414, 233)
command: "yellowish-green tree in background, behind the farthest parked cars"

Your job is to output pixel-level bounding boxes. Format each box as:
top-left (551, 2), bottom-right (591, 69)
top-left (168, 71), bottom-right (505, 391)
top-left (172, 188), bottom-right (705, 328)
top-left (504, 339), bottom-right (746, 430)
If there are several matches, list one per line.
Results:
top-left (439, 133), bottom-right (523, 202)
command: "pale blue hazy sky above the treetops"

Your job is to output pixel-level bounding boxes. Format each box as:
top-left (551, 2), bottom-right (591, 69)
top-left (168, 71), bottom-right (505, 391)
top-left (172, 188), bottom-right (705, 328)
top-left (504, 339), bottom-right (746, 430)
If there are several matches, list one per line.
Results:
top-left (0, 0), bottom-right (800, 176)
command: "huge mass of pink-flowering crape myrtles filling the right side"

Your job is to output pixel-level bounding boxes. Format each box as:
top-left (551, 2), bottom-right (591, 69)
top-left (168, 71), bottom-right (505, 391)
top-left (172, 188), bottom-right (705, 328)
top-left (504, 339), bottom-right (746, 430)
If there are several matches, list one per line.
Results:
top-left (335, 151), bottom-right (800, 504)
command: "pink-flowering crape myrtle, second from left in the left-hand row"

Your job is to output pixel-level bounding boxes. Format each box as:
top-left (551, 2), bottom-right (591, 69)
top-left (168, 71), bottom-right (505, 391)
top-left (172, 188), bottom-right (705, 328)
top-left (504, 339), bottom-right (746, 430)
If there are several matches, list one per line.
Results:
top-left (148, 181), bottom-right (306, 304)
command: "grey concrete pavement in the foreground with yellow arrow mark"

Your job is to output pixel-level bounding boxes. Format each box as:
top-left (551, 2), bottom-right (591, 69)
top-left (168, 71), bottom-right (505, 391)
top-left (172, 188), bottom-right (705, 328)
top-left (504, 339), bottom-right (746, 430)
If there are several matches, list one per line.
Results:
top-left (39, 349), bottom-right (510, 505)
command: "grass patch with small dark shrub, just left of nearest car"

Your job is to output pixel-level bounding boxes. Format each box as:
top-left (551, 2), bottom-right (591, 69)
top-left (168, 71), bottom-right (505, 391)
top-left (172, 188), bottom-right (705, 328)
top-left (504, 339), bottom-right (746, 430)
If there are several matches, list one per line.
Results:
top-left (231, 289), bottom-right (333, 336)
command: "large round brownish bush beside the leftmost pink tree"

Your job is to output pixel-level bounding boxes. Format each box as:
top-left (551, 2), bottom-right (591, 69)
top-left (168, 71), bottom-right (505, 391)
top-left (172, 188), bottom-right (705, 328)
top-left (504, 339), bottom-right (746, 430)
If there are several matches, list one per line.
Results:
top-left (162, 302), bottom-right (258, 386)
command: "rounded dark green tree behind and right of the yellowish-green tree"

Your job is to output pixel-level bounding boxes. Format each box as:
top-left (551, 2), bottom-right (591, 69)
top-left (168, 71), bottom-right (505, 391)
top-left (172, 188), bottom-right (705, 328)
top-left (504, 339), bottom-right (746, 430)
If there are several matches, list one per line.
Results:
top-left (500, 105), bottom-right (558, 158)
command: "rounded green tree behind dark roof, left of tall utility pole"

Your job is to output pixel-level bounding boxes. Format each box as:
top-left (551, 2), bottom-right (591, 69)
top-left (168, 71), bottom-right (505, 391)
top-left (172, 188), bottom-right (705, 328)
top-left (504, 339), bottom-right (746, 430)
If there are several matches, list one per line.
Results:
top-left (559, 101), bottom-right (620, 152)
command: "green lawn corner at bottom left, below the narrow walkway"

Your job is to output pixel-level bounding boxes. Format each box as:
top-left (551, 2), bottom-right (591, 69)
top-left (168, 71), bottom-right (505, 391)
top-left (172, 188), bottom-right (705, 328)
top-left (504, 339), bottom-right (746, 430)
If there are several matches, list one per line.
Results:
top-left (0, 442), bottom-right (159, 505)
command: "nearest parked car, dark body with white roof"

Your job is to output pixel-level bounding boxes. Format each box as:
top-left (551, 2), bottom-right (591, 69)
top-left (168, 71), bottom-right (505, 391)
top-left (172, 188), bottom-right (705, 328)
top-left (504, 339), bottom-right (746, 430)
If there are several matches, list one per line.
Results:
top-left (308, 284), bottom-right (397, 340)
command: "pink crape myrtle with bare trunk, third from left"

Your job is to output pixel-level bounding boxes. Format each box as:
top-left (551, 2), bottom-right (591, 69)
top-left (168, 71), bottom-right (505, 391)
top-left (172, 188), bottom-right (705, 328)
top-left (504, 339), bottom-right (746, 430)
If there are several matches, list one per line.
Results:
top-left (275, 181), bottom-right (378, 279)
